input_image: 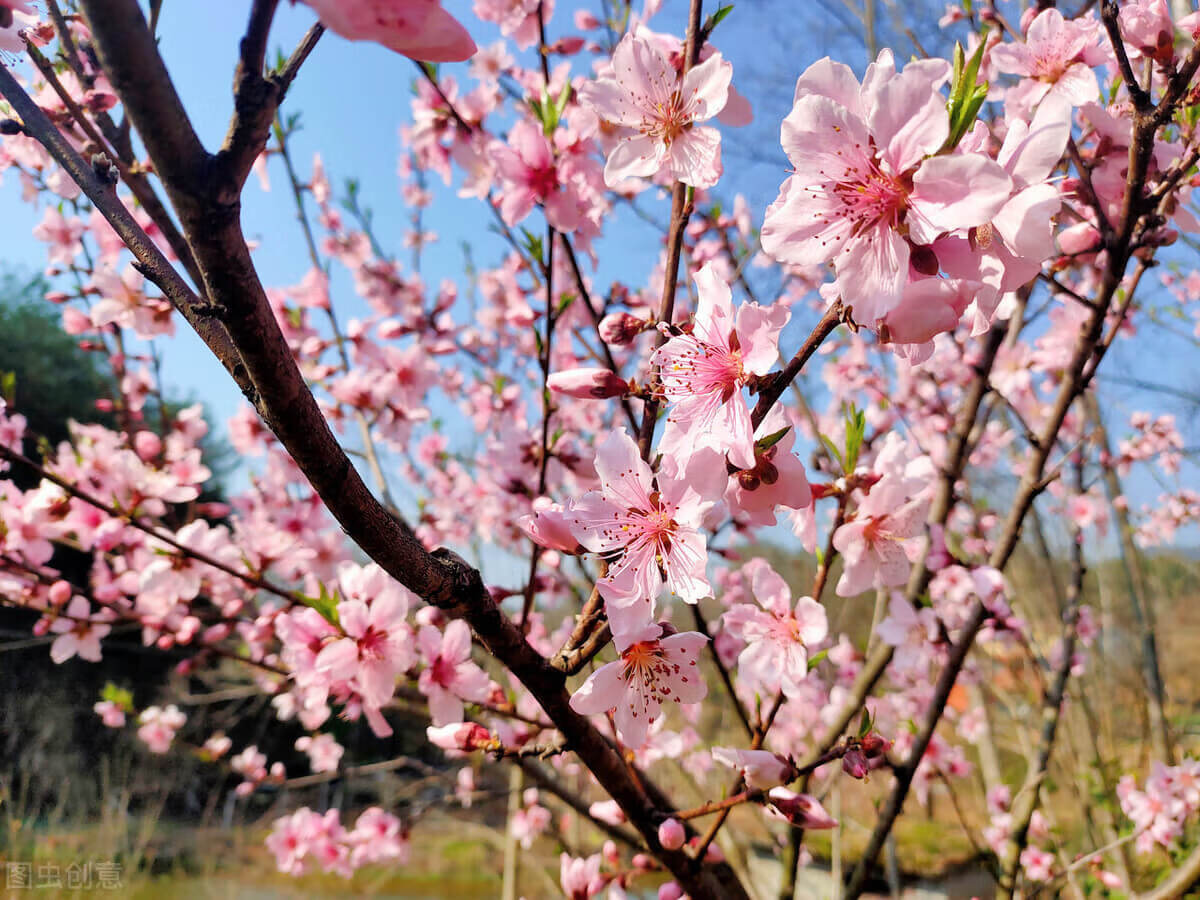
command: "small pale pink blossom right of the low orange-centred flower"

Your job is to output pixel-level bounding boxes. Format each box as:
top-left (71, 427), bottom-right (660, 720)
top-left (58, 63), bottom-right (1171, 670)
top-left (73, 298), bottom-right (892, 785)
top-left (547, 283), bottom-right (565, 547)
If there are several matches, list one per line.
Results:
top-left (722, 559), bottom-right (829, 697)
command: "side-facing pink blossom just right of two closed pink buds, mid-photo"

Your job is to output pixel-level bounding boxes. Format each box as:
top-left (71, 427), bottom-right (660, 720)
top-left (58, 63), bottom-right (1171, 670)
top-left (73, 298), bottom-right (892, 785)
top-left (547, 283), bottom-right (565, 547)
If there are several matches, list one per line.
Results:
top-left (650, 264), bottom-right (788, 469)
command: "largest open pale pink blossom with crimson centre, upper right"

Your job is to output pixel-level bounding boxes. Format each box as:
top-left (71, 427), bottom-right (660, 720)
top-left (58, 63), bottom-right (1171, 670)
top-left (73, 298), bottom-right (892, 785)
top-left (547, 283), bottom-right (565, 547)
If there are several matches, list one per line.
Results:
top-left (762, 50), bottom-right (1012, 326)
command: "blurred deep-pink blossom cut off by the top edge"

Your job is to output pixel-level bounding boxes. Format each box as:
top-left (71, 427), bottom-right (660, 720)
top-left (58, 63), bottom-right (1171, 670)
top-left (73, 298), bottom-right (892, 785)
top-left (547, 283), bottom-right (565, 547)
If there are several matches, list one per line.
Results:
top-left (293, 0), bottom-right (475, 62)
